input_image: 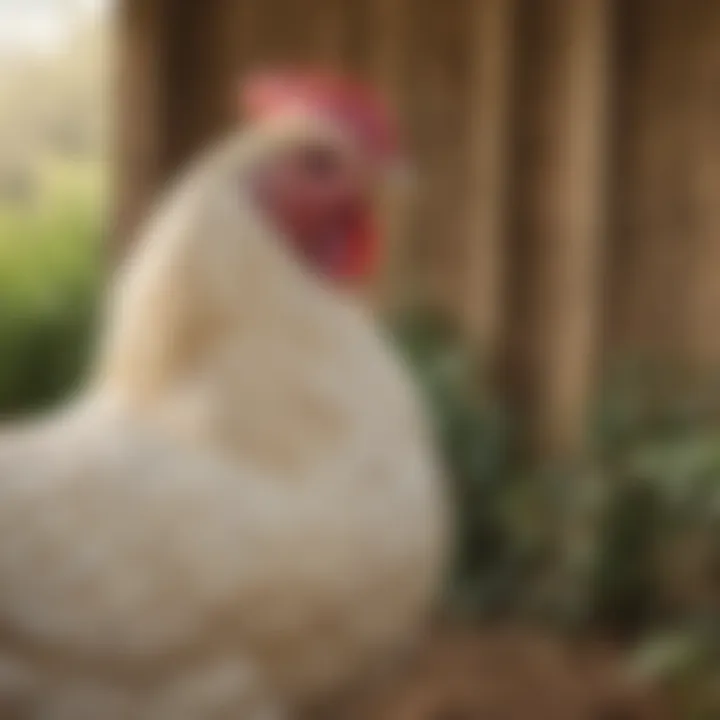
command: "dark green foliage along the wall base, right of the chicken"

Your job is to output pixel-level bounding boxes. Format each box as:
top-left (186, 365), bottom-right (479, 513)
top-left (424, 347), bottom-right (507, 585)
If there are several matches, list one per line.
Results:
top-left (396, 317), bottom-right (720, 720)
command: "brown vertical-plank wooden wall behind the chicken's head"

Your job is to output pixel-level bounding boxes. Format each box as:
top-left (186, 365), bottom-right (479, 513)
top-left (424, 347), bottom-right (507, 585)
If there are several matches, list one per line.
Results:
top-left (118, 0), bottom-right (720, 451)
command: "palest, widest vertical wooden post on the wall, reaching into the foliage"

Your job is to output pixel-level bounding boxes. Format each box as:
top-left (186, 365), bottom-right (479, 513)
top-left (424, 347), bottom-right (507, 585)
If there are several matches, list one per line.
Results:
top-left (518, 0), bottom-right (609, 455)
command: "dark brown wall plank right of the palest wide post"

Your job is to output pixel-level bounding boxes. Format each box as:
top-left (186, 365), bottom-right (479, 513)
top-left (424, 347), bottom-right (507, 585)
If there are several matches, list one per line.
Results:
top-left (606, 0), bottom-right (704, 363)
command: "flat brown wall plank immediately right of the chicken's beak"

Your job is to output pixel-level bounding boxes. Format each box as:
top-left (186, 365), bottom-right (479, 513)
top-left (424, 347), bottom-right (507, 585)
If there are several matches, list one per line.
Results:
top-left (408, 0), bottom-right (471, 319)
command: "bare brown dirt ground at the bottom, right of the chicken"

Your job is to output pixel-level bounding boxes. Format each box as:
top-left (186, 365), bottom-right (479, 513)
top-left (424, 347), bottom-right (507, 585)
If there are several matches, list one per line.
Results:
top-left (358, 627), bottom-right (678, 720)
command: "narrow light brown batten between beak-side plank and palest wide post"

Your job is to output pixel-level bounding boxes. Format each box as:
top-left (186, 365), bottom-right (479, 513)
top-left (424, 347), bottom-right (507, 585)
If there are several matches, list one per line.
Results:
top-left (463, 0), bottom-right (515, 366)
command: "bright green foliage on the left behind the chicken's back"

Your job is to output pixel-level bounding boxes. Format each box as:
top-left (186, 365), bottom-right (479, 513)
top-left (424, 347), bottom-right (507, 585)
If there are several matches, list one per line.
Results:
top-left (0, 166), bottom-right (101, 415)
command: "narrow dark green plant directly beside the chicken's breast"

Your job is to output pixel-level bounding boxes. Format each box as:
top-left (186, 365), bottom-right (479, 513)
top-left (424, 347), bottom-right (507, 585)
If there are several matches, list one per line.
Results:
top-left (393, 313), bottom-right (520, 611)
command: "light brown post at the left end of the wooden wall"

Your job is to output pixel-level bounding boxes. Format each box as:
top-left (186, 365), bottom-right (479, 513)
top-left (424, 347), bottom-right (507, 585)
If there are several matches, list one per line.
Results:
top-left (114, 0), bottom-right (172, 250)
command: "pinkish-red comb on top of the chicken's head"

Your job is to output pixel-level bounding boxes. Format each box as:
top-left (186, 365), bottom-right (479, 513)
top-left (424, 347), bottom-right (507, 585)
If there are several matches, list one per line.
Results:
top-left (242, 72), bottom-right (399, 161)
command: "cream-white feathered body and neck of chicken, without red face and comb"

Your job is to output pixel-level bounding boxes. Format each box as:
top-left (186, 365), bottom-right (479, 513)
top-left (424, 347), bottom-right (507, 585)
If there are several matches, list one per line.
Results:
top-left (0, 74), bottom-right (447, 720)
